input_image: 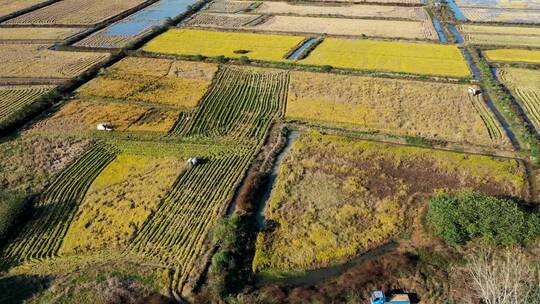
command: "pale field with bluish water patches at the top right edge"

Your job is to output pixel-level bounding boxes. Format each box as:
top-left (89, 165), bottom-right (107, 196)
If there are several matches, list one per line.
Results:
top-left (461, 7), bottom-right (540, 24)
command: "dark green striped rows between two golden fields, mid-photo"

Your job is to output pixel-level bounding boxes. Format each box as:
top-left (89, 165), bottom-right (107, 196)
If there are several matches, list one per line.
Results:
top-left (173, 67), bottom-right (289, 140)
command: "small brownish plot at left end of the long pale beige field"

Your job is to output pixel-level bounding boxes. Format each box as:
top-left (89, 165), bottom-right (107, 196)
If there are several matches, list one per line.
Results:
top-left (184, 13), bottom-right (260, 28)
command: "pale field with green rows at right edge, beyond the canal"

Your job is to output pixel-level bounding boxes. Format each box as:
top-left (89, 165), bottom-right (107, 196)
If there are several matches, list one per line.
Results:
top-left (499, 68), bottom-right (540, 131)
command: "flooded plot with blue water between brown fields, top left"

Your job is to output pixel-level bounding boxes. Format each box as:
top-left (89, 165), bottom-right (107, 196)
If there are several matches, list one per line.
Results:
top-left (75, 0), bottom-right (197, 48)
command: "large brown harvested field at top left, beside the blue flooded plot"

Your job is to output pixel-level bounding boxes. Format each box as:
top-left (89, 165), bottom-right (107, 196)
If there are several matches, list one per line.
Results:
top-left (4, 0), bottom-right (144, 26)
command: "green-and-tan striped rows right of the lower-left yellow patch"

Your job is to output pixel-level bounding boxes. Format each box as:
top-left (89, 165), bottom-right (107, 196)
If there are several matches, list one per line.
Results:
top-left (130, 153), bottom-right (252, 290)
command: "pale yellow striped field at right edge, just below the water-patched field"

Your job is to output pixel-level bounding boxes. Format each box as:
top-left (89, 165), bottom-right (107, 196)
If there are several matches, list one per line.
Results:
top-left (460, 24), bottom-right (540, 47)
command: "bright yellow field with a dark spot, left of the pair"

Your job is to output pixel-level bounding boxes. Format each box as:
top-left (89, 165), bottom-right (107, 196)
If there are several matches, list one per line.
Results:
top-left (143, 29), bottom-right (304, 61)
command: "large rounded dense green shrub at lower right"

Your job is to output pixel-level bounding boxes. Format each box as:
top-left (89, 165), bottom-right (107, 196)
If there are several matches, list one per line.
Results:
top-left (427, 191), bottom-right (540, 246)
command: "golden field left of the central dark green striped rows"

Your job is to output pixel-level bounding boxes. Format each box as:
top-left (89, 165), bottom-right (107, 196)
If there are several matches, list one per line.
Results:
top-left (77, 57), bottom-right (217, 109)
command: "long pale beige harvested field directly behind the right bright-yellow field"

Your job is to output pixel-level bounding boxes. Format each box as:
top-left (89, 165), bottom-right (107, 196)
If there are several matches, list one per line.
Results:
top-left (254, 16), bottom-right (439, 40)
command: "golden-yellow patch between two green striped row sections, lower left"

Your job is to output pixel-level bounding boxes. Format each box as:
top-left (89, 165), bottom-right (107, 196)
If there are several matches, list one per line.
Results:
top-left (60, 154), bottom-right (185, 253)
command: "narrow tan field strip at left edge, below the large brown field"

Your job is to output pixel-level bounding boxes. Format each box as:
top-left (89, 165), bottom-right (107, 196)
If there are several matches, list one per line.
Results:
top-left (0, 27), bottom-right (86, 42)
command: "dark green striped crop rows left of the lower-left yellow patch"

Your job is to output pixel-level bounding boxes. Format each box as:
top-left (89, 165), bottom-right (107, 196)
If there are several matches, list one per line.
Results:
top-left (3, 144), bottom-right (116, 260)
